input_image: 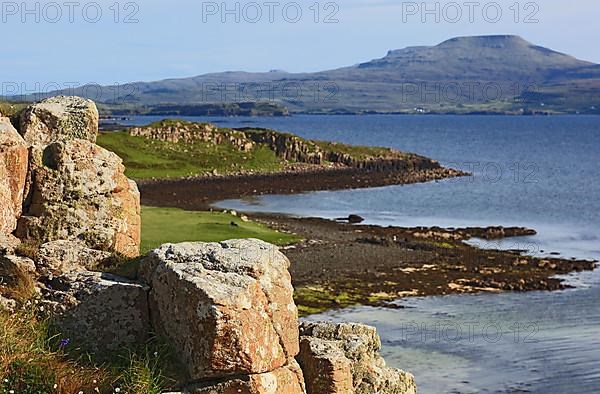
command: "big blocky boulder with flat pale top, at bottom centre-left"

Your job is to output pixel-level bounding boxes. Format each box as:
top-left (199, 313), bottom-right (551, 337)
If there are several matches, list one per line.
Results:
top-left (141, 240), bottom-right (298, 380)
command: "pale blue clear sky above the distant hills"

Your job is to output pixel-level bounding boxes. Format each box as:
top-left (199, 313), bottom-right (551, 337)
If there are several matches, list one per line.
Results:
top-left (0, 0), bottom-right (600, 95)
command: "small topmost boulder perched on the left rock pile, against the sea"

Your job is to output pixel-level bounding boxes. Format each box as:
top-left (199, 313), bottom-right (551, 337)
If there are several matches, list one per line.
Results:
top-left (20, 96), bottom-right (99, 146)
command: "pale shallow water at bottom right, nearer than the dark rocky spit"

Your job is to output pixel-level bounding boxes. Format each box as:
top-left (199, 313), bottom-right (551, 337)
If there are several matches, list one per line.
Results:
top-left (310, 266), bottom-right (600, 394)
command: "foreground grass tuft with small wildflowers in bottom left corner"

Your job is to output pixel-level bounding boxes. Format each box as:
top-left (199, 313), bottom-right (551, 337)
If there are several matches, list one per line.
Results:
top-left (0, 307), bottom-right (179, 394)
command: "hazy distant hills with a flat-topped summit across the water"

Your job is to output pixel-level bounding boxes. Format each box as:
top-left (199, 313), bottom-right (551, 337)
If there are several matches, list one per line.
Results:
top-left (10, 35), bottom-right (600, 114)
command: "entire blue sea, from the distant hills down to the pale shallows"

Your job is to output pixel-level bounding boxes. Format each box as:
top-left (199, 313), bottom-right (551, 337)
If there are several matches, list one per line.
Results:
top-left (127, 116), bottom-right (600, 393)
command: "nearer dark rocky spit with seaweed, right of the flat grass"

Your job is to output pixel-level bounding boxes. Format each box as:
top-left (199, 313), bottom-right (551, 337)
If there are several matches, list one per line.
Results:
top-left (255, 215), bottom-right (597, 314)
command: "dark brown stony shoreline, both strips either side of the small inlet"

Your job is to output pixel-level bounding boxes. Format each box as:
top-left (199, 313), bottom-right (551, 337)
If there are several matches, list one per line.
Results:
top-left (139, 169), bottom-right (597, 316)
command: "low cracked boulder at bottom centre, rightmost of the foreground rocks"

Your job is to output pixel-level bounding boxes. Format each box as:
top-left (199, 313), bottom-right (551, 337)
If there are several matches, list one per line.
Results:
top-left (297, 322), bottom-right (417, 394)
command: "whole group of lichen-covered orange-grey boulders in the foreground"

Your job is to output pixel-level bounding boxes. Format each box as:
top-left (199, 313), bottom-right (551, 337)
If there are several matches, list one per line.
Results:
top-left (0, 97), bottom-right (416, 394)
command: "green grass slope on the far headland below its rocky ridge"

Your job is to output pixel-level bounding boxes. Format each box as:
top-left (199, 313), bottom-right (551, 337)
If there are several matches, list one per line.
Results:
top-left (98, 132), bottom-right (283, 179)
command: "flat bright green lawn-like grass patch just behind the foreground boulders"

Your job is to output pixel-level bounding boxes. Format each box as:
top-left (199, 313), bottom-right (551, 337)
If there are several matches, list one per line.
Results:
top-left (141, 207), bottom-right (299, 253)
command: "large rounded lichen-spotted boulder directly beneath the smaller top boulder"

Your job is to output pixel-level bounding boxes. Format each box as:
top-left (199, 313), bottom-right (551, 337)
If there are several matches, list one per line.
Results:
top-left (17, 139), bottom-right (141, 257)
